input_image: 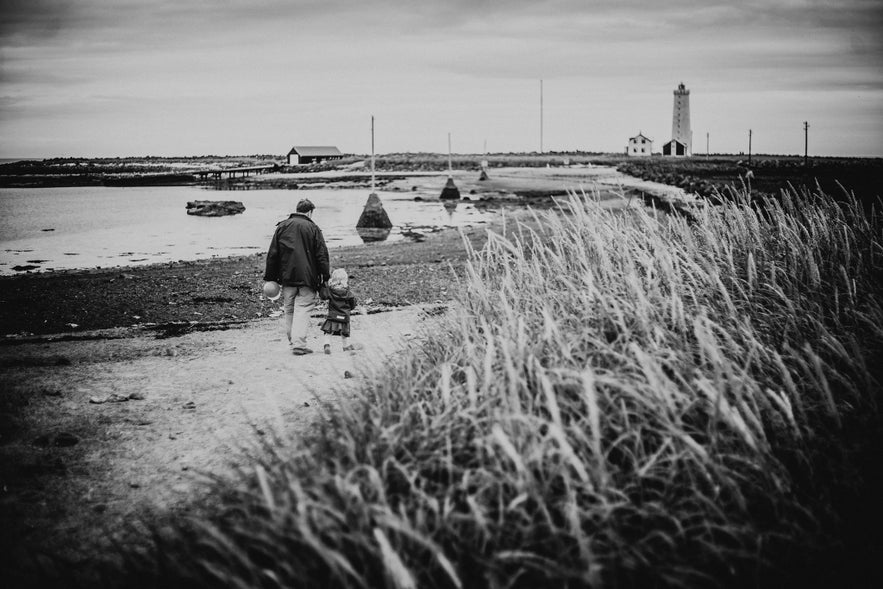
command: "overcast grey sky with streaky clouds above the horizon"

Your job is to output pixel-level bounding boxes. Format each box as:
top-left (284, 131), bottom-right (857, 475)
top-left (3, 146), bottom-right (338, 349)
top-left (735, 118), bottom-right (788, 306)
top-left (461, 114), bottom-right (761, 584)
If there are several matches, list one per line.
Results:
top-left (0, 0), bottom-right (883, 157)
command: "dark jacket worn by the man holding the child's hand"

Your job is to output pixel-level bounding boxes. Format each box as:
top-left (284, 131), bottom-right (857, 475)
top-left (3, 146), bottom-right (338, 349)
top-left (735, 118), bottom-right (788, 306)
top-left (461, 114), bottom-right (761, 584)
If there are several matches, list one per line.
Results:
top-left (264, 213), bottom-right (331, 289)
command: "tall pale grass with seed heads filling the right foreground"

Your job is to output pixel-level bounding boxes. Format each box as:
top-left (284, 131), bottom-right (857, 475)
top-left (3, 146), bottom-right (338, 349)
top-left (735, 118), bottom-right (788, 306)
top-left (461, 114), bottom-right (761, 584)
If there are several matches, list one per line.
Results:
top-left (121, 187), bottom-right (883, 588)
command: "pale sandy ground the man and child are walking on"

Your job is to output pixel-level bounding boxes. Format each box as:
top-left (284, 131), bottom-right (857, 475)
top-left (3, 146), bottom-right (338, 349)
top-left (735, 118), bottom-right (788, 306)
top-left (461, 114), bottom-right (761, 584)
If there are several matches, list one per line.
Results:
top-left (0, 306), bottom-right (444, 560)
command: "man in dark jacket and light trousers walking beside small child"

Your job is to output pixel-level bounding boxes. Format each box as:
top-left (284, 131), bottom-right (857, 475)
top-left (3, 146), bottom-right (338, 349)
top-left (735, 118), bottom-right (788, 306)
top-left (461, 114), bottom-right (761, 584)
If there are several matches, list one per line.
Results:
top-left (264, 198), bottom-right (331, 356)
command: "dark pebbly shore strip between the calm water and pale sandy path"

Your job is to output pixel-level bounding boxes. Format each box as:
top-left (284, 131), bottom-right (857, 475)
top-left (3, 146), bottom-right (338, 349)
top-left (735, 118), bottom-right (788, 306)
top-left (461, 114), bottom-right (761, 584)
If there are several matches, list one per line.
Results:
top-left (0, 222), bottom-right (498, 341)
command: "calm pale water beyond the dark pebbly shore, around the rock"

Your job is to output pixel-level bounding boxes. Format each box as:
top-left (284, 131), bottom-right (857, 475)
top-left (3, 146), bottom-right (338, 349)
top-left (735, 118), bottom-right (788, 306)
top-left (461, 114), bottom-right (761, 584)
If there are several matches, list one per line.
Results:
top-left (0, 186), bottom-right (498, 275)
